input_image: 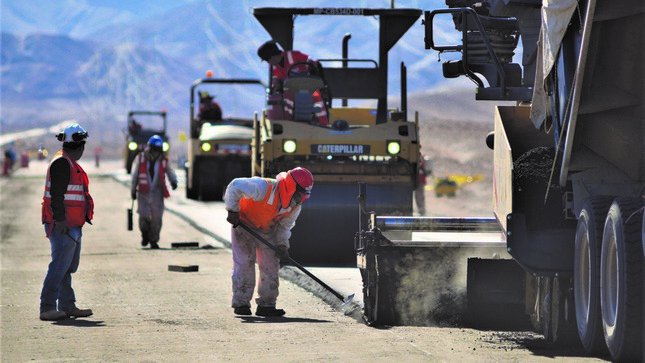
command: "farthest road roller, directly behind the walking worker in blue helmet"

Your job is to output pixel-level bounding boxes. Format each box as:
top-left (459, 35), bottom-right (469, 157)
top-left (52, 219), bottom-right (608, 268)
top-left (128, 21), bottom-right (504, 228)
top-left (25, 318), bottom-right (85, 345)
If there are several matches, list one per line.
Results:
top-left (123, 111), bottom-right (170, 174)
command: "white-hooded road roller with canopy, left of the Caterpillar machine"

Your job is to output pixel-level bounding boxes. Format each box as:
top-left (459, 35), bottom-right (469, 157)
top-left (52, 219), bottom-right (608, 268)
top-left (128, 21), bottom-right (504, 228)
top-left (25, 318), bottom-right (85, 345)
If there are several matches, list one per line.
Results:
top-left (185, 71), bottom-right (266, 201)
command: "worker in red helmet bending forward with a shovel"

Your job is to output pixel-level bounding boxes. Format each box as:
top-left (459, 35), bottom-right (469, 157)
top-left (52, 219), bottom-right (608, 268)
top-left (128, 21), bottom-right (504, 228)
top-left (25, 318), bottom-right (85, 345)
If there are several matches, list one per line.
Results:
top-left (224, 167), bottom-right (314, 316)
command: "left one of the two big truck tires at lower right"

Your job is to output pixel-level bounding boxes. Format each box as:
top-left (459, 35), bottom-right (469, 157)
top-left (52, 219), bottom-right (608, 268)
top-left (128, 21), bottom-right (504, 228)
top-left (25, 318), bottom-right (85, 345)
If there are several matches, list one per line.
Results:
top-left (573, 196), bottom-right (612, 354)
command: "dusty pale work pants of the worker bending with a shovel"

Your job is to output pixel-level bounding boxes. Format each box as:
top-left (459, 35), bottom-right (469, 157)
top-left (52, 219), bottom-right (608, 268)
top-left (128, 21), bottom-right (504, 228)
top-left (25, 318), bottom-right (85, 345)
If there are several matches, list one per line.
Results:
top-left (231, 227), bottom-right (280, 308)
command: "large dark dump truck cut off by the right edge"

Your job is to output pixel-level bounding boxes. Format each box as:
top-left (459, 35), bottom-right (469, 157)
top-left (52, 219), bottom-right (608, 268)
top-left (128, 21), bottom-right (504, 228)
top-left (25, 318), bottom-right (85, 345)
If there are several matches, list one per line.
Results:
top-left (359, 0), bottom-right (645, 361)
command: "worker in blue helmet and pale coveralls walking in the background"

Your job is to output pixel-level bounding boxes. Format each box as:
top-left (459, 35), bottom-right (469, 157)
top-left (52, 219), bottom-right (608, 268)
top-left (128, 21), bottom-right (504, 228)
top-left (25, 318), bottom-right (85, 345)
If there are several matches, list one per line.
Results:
top-left (130, 135), bottom-right (177, 249)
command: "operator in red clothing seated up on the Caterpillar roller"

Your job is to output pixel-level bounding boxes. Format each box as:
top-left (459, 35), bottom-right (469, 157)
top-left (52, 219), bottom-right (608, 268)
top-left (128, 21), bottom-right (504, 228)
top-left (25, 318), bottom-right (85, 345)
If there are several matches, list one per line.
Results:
top-left (258, 40), bottom-right (329, 126)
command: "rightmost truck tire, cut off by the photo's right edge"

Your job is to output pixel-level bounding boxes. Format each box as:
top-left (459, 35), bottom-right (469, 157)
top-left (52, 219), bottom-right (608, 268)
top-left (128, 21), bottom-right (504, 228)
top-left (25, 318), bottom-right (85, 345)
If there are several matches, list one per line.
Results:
top-left (600, 198), bottom-right (643, 361)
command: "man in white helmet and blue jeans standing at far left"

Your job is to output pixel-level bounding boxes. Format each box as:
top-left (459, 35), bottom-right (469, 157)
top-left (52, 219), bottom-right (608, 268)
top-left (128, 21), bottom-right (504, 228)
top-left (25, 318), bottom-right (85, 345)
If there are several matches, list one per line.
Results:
top-left (40, 124), bottom-right (94, 320)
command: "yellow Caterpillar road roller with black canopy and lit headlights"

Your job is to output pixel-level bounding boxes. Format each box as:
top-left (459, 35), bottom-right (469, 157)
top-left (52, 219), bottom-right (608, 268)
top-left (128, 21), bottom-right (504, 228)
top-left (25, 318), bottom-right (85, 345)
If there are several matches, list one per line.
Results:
top-left (252, 8), bottom-right (421, 265)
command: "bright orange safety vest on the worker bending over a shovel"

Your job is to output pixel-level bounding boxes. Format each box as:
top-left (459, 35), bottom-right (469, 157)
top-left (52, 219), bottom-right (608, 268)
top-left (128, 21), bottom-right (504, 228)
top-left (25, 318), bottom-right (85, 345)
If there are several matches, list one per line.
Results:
top-left (240, 179), bottom-right (293, 233)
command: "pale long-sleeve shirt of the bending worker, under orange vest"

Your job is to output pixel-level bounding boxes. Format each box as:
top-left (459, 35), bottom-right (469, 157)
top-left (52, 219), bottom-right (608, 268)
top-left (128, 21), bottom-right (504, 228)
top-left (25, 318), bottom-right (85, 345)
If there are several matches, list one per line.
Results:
top-left (224, 177), bottom-right (301, 248)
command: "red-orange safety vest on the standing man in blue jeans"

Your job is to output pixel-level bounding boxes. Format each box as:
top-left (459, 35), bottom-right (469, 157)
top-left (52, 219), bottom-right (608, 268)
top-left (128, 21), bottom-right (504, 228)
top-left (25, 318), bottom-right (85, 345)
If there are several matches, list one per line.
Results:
top-left (42, 153), bottom-right (94, 227)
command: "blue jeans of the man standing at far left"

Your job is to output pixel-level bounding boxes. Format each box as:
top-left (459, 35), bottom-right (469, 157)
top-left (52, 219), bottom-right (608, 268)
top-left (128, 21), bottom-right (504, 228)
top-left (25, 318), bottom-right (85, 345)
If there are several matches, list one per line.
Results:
top-left (40, 224), bottom-right (83, 313)
